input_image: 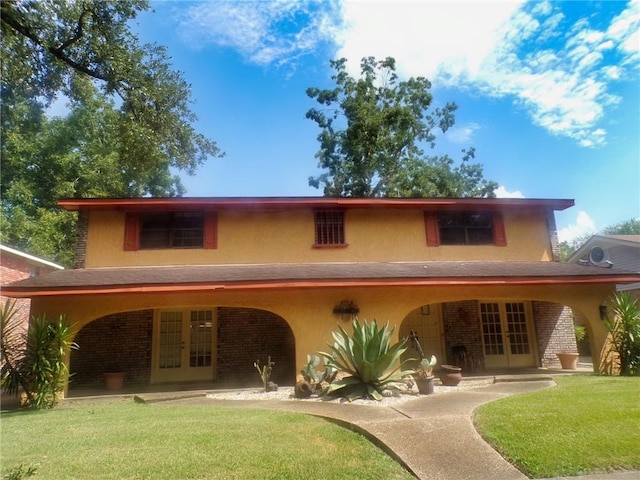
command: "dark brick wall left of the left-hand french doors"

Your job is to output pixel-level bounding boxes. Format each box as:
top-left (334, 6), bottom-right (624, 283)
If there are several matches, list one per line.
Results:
top-left (70, 310), bottom-right (153, 388)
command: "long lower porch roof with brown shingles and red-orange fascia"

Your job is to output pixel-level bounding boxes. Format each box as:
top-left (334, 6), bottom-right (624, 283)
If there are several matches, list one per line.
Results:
top-left (3, 261), bottom-right (640, 297)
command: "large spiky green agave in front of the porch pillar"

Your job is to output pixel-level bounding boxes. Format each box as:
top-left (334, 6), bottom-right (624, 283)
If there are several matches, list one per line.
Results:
top-left (318, 319), bottom-right (413, 400)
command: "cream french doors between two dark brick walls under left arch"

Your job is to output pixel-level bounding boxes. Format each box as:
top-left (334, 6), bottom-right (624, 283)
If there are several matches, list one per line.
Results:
top-left (151, 309), bottom-right (216, 383)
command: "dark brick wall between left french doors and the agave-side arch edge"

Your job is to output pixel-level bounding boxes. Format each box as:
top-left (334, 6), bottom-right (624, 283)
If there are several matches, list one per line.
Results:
top-left (218, 307), bottom-right (296, 386)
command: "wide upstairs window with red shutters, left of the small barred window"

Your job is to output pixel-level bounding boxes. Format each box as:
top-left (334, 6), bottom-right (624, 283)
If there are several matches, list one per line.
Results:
top-left (124, 212), bottom-right (217, 250)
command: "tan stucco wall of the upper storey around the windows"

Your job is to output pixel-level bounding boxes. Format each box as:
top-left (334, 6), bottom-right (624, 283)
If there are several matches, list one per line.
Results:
top-left (86, 209), bottom-right (551, 268)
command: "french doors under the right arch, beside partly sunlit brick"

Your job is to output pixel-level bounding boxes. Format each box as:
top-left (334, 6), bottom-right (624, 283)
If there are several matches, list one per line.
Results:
top-left (480, 302), bottom-right (535, 368)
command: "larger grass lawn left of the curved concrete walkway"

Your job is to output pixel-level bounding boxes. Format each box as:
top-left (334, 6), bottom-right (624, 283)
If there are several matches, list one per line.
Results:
top-left (0, 401), bottom-right (413, 480)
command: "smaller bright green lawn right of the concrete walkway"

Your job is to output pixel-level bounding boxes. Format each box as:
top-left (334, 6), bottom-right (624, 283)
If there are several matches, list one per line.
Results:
top-left (474, 375), bottom-right (640, 478)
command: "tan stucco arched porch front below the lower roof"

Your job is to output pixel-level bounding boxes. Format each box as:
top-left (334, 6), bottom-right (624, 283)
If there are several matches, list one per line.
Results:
top-left (28, 284), bottom-right (613, 378)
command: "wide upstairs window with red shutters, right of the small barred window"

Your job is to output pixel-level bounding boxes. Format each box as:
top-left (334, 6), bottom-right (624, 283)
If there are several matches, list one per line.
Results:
top-left (425, 212), bottom-right (507, 246)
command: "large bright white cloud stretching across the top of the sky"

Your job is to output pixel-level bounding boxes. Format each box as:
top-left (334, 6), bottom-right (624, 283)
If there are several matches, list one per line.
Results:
top-left (181, 0), bottom-right (640, 147)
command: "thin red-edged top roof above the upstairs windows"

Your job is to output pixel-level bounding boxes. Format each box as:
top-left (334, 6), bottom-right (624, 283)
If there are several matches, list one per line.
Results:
top-left (58, 197), bottom-right (574, 211)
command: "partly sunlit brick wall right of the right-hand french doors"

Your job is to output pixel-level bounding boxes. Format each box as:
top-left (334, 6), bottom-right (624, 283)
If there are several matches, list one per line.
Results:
top-left (532, 302), bottom-right (578, 368)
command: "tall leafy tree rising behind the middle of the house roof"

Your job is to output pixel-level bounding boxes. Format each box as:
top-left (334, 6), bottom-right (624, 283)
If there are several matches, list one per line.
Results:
top-left (307, 57), bottom-right (497, 197)
